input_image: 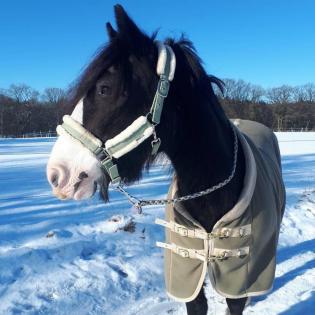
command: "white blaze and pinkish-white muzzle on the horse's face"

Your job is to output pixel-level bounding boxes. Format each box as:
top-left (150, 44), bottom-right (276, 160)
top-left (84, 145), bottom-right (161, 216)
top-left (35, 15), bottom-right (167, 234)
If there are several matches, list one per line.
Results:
top-left (47, 99), bottom-right (102, 200)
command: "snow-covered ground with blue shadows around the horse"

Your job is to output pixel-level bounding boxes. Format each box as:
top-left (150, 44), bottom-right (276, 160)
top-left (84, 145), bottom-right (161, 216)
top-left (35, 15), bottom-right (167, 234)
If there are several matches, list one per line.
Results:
top-left (0, 133), bottom-right (315, 315)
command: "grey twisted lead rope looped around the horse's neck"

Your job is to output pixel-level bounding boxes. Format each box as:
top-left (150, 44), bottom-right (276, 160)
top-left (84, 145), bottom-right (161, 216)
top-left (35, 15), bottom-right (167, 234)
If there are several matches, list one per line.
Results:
top-left (114, 124), bottom-right (238, 213)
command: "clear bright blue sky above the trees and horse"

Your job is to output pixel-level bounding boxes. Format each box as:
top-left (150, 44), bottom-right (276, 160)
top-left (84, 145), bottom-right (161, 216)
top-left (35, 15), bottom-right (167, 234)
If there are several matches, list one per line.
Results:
top-left (0, 0), bottom-right (315, 91)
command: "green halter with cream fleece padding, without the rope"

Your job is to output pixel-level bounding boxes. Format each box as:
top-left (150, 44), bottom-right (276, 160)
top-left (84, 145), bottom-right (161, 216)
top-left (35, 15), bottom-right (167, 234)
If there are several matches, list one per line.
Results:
top-left (57, 42), bottom-right (176, 185)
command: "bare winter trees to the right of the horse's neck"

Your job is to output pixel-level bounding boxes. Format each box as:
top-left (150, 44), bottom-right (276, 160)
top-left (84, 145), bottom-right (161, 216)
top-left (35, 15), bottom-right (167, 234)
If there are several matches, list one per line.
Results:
top-left (216, 79), bottom-right (315, 131)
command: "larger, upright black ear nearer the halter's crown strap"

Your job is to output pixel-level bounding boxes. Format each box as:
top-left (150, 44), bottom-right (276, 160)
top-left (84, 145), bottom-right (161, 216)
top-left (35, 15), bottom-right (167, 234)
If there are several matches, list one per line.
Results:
top-left (114, 4), bottom-right (147, 45)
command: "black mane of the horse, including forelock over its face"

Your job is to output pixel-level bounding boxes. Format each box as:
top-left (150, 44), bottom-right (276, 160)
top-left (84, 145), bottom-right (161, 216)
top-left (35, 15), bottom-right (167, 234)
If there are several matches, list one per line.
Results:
top-left (67, 31), bottom-right (224, 121)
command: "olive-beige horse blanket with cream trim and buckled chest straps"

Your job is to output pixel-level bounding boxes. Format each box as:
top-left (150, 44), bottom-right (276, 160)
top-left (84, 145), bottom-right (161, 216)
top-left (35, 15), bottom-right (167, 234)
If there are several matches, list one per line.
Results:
top-left (156, 120), bottom-right (285, 302)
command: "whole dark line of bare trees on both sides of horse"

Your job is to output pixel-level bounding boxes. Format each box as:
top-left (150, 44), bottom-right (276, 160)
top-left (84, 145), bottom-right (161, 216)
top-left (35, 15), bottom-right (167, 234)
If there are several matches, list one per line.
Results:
top-left (0, 79), bottom-right (315, 137)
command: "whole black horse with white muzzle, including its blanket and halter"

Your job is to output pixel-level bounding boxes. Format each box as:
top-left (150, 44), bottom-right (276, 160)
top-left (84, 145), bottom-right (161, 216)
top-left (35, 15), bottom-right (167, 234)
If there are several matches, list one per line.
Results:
top-left (47, 5), bottom-right (285, 315)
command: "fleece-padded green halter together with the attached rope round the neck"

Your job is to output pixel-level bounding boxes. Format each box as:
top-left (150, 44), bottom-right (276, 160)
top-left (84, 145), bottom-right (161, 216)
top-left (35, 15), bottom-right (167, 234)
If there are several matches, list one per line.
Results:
top-left (57, 42), bottom-right (238, 212)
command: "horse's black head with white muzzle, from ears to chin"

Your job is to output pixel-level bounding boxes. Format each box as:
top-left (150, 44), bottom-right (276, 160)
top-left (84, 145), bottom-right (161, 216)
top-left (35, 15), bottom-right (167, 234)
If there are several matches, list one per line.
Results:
top-left (47, 5), bottom-right (181, 200)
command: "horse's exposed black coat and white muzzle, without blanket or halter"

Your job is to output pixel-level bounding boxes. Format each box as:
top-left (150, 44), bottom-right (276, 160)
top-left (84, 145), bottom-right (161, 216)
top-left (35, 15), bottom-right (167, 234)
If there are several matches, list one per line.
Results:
top-left (48, 5), bottom-right (286, 315)
